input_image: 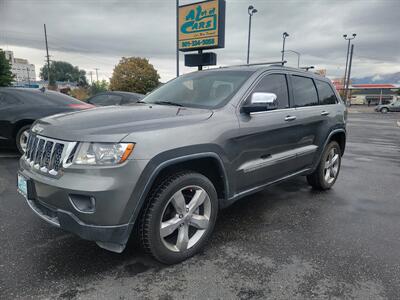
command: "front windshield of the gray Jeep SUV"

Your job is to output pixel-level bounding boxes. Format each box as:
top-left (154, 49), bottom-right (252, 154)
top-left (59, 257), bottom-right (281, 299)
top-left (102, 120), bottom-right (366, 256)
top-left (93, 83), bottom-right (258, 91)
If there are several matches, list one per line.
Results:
top-left (142, 70), bottom-right (253, 108)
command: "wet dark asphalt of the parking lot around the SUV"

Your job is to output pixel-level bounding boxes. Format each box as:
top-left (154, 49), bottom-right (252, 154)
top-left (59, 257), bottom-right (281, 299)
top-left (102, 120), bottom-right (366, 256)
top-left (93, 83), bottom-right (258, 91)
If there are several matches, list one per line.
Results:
top-left (0, 113), bottom-right (400, 299)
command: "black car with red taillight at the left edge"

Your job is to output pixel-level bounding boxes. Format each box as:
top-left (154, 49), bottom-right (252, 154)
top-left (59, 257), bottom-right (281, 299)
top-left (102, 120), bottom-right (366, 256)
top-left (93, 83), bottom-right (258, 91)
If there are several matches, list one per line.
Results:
top-left (0, 88), bottom-right (94, 154)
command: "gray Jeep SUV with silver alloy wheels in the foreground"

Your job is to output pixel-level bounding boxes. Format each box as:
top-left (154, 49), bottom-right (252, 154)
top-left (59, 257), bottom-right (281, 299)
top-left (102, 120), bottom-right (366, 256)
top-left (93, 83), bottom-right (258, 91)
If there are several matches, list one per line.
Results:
top-left (18, 65), bottom-right (347, 264)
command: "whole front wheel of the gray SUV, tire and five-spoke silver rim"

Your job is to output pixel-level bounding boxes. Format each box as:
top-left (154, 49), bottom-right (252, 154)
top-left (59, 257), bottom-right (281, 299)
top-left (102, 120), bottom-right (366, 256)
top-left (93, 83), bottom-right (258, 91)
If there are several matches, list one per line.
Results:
top-left (139, 171), bottom-right (218, 264)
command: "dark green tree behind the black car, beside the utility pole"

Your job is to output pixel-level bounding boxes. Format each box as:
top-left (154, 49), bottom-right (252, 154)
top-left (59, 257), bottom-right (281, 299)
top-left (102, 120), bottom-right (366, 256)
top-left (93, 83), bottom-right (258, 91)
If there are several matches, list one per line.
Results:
top-left (40, 61), bottom-right (87, 86)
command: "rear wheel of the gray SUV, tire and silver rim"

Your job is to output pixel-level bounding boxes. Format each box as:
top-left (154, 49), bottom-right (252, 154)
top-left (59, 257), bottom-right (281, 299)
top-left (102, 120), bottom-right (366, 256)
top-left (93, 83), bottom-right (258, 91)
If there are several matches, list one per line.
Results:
top-left (307, 141), bottom-right (342, 191)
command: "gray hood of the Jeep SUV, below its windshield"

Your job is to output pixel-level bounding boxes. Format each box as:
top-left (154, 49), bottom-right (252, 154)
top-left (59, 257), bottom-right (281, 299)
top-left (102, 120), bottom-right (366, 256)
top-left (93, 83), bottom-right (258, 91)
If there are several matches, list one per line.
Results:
top-left (32, 104), bottom-right (213, 142)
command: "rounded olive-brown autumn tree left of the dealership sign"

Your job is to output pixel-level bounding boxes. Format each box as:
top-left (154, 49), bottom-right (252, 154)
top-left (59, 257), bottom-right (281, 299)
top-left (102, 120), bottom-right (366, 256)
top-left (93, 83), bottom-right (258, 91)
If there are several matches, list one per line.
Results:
top-left (110, 57), bottom-right (160, 94)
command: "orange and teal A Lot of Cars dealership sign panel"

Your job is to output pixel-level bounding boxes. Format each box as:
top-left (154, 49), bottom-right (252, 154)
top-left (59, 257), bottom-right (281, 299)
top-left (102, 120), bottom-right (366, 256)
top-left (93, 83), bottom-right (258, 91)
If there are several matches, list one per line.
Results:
top-left (178, 0), bottom-right (225, 51)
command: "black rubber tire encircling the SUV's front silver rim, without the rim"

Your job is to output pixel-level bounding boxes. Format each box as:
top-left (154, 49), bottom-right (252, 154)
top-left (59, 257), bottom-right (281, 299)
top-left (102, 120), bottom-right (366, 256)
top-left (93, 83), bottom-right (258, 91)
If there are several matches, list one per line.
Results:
top-left (148, 173), bottom-right (218, 264)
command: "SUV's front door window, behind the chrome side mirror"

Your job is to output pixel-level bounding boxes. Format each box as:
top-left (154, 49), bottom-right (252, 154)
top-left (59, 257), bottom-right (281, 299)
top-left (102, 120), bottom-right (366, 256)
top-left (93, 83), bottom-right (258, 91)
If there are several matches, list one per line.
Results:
top-left (253, 74), bottom-right (289, 108)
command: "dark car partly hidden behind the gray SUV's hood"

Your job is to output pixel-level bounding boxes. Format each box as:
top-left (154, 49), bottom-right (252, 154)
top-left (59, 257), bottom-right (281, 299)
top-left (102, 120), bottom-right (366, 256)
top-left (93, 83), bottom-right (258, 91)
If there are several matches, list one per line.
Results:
top-left (86, 92), bottom-right (144, 106)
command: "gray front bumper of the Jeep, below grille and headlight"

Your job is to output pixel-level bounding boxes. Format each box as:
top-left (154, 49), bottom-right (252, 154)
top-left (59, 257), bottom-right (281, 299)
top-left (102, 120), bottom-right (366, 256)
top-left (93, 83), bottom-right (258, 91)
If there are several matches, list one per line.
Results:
top-left (19, 159), bottom-right (146, 248)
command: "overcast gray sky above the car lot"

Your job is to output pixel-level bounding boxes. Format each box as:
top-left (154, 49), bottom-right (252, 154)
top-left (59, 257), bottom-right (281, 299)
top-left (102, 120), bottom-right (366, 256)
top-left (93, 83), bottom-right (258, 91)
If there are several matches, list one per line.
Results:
top-left (0, 0), bottom-right (400, 81)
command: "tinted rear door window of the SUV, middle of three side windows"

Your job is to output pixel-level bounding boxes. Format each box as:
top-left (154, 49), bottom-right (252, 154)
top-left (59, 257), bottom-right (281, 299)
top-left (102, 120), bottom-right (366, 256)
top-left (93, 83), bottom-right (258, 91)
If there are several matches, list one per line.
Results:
top-left (292, 76), bottom-right (318, 107)
